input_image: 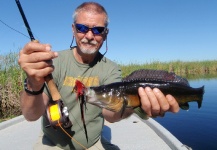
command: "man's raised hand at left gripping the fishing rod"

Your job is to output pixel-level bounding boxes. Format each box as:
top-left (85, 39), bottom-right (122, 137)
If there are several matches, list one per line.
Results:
top-left (18, 42), bottom-right (58, 91)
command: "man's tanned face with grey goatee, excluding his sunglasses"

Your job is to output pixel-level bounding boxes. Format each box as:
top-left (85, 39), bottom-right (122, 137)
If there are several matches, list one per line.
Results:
top-left (73, 12), bottom-right (106, 54)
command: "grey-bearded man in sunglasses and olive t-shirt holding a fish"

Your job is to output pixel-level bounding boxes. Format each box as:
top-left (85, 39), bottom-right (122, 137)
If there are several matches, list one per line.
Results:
top-left (19, 2), bottom-right (179, 149)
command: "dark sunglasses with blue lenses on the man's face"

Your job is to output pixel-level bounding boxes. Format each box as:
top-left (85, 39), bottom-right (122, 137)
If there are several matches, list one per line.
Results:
top-left (75, 24), bottom-right (106, 35)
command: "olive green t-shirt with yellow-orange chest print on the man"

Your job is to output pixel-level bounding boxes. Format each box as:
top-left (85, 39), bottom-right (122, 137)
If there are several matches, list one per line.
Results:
top-left (42, 50), bottom-right (121, 149)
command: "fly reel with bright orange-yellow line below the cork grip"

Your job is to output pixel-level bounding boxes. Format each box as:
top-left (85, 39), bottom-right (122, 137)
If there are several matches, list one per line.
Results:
top-left (46, 100), bottom-right (72, 128)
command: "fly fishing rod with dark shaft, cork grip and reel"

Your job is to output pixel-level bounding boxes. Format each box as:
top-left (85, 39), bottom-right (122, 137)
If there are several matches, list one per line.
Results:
top-left (15, 0), bottom-right (72, 128)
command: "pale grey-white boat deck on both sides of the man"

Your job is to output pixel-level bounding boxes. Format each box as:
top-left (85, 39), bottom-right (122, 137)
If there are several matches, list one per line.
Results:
top-left (0, 115), bottom-right (187, 150)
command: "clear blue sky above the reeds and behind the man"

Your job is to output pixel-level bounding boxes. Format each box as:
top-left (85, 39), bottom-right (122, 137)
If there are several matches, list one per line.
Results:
top-left (0, 0), bottom-right (217, 64)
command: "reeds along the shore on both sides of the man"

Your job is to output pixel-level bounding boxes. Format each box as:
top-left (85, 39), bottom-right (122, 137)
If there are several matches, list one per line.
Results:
top-left (0, 53), bottom-right (217, 122)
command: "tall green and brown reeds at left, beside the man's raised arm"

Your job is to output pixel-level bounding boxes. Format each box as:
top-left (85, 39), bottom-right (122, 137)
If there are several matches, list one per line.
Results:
top-left (0, 52), bottom-right (23, 119)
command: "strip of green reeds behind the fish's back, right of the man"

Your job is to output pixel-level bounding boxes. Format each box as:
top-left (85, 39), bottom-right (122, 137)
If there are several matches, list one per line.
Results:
top-left (120, 60), bottom-right (217, 79)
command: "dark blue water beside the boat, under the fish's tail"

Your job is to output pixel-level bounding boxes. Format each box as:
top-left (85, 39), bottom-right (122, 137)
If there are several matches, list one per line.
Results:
top-left (155, 79), bottom-right (217, 150)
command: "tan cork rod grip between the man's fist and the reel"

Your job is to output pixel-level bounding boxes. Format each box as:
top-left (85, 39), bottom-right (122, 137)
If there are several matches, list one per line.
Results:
top-left (45, 74), bottom-right (61, 101)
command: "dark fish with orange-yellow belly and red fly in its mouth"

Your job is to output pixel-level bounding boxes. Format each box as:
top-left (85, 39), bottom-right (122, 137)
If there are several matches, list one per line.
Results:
top-left (75, 69), bottom-right (204, 112)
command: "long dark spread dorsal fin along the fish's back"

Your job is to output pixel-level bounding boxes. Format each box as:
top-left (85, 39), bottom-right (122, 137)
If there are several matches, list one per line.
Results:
top-left (123, 69), bottom-right (189, 86)
